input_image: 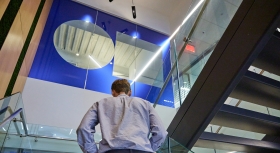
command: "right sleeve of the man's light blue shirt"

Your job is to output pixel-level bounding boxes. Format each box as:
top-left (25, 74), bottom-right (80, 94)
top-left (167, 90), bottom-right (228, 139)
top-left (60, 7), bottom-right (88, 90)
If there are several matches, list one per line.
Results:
top-left (149, 104), bottom-right (167, 151)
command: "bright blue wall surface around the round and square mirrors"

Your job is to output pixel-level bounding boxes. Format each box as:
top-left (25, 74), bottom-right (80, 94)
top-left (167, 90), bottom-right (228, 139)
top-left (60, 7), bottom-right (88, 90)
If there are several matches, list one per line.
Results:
top-left (29, 0), bottom-right (174, 107)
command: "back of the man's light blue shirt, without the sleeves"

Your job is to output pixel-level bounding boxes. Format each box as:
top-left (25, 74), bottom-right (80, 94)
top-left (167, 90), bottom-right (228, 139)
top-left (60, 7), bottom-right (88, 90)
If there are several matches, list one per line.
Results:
top-left (97, 94), bottom-right (153, 152)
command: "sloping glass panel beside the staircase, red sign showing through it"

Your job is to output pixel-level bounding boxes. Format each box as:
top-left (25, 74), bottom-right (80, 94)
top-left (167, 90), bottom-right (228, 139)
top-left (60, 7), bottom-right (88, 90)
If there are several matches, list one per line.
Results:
top-left (173, 0), bottom-right (242, 103)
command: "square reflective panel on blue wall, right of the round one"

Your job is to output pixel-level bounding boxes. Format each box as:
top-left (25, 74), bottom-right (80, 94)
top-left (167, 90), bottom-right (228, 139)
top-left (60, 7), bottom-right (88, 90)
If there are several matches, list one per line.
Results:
top-left (113, 32), bottom-right (163, 87)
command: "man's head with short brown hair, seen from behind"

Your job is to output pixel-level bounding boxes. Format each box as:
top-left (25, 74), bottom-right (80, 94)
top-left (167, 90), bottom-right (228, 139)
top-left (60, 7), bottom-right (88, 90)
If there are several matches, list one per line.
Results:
top-left (111, 79), bottom-right (131, 97)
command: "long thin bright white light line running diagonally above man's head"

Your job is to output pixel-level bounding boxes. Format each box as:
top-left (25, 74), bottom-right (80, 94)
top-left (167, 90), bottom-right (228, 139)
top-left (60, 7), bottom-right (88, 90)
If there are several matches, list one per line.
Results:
top-left (130, 0), bottom-right (204, 85)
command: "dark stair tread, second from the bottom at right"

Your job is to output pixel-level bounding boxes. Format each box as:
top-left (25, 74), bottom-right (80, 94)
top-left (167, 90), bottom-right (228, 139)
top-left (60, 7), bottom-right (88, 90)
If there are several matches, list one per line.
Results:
top-left (211, 105), bottom-right (280, 136)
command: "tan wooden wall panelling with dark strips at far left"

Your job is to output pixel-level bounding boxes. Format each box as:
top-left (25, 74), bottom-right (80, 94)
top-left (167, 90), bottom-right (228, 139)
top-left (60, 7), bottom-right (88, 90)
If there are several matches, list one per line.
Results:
top-left (0, 0), bottom-right (52, 98)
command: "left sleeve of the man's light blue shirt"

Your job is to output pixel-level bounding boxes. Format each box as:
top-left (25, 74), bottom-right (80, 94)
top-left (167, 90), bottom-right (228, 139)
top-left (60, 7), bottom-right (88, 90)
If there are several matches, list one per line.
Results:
top-left (76, 103), bottom-right (99, 153)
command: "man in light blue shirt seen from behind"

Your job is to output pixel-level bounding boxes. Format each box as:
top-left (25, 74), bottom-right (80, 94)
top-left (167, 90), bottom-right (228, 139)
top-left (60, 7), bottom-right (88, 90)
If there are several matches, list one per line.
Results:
top-left (76, 79), bottom-right (167, 153)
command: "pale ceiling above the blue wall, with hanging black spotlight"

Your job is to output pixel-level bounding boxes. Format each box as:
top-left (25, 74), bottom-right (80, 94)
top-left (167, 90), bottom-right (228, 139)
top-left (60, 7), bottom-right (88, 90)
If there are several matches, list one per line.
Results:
top-left (73, 0), bottom-right (192, 35)
